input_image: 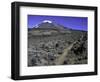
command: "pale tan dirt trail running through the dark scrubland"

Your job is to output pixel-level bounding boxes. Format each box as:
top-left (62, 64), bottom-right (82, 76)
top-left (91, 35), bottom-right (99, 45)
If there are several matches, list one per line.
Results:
top-left (55, 41), bottom-right (76, 65)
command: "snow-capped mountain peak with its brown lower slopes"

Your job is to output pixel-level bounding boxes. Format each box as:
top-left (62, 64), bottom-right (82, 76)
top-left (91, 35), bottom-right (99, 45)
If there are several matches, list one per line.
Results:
top-left (29, 20), bottom-right (71, 37)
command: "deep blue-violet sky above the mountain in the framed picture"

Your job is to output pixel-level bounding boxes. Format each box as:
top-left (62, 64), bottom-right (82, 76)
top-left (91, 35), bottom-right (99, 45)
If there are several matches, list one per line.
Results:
top-left (28, 15), bottom-right (88, 31)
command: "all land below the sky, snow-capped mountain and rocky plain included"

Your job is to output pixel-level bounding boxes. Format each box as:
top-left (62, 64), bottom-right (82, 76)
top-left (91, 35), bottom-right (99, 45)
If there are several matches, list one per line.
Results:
top-left (28, 21), bottom-right (88, 66)
